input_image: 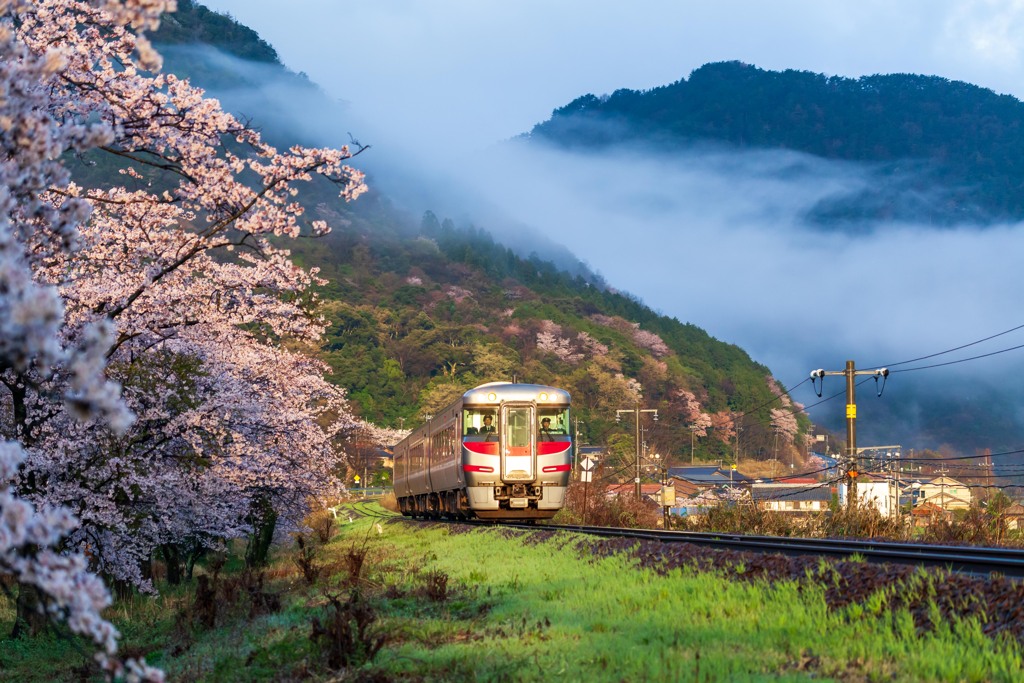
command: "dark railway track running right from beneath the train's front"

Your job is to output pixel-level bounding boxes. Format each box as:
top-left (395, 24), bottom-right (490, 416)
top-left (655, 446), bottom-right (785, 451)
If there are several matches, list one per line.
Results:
top-left (464, 523), bottom-right (1024, 579)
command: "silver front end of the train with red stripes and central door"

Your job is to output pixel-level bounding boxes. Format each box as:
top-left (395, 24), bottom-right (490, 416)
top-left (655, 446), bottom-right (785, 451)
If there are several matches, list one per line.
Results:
top-left (461, 382), bottom-right (572, 519)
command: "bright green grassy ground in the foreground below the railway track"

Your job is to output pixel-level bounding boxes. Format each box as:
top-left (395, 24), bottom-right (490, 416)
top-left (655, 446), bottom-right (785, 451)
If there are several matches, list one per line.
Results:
top-left (0, 501), bottom-right (1024, 682)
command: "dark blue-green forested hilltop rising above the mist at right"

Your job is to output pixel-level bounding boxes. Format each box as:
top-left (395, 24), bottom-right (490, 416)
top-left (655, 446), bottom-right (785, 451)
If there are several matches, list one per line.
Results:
top-left (529, 61), bottom-right (1024, 226)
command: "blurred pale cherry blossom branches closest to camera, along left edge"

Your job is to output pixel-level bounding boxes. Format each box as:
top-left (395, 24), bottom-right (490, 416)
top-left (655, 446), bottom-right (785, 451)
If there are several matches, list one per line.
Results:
top-left (0, 0), bottom-right (173, 680)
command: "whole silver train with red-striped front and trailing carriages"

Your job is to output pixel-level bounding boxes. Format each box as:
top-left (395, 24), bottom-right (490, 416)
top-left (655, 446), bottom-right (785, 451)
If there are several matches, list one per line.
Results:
top-left (393, 382), bottom-right (572, 521)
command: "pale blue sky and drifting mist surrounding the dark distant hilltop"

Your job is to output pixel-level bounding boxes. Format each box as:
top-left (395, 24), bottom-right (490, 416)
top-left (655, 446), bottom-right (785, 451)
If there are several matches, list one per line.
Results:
top-left (199, 0), bottom-right (1024, 445)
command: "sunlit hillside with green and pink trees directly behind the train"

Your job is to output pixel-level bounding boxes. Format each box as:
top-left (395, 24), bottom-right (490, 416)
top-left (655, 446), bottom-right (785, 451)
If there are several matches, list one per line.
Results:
top-left (286, 202), bottom-right (809, 460)
